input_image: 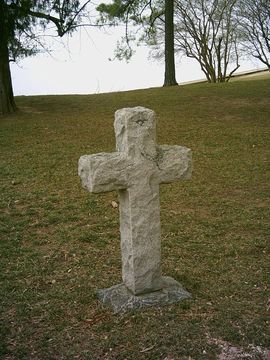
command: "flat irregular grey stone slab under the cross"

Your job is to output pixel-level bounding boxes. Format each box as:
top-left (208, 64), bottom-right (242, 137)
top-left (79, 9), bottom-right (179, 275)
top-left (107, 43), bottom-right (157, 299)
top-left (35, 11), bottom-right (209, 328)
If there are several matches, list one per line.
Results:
top-left (97, 276), bottom-right (191, 313)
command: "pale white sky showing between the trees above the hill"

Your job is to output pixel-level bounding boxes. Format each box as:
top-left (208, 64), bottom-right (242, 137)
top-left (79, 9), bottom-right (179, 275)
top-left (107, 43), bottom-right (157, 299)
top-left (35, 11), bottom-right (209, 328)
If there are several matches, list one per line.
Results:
top-left (11, 28), bottom-right (262, 95)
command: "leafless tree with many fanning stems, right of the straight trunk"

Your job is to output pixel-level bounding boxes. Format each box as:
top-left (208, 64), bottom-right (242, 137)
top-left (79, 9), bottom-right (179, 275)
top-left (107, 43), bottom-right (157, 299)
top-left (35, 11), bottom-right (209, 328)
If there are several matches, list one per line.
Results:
top-left (175, 0), bottom-right (240, 83)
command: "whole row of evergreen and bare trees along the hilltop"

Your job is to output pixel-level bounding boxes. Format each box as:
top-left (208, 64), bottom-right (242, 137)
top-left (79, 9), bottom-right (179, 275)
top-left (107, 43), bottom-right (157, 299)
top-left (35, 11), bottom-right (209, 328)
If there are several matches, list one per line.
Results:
top-left (0, 0), bottom-right (270, 115)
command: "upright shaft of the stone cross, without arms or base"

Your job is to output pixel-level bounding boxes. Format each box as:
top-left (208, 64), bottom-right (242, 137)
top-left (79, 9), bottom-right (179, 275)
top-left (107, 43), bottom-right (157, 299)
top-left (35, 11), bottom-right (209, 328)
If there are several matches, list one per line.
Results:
top-left (114, 109), bottom-right (162, 295)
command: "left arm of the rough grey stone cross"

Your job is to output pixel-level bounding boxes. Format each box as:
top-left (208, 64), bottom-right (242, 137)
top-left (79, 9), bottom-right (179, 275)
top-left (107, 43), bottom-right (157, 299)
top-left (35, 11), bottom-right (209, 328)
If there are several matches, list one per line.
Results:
top-left (78, 152), bottom-right (128, 193)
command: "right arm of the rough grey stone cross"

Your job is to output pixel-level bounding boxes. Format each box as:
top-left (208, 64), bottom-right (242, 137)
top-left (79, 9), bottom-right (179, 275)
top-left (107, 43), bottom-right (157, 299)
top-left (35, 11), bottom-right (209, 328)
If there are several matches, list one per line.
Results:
top-left (157, 145), bottom-right (192, 183)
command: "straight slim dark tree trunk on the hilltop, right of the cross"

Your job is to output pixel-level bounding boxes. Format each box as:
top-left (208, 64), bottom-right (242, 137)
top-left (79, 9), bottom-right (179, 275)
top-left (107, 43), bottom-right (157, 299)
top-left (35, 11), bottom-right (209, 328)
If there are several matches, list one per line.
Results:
top-left (163, 0), bottom-right (178, 86)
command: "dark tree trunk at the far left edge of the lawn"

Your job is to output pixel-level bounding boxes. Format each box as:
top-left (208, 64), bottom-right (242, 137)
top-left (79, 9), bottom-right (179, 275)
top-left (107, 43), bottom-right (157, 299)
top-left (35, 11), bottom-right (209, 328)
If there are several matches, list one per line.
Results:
top-left (0, 0), bottom-right (16, 115)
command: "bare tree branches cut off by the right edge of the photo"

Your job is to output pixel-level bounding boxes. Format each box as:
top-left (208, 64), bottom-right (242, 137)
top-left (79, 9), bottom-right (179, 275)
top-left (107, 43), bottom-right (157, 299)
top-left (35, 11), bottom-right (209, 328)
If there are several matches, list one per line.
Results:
top-left (238, 0), bottom-right (270, 71)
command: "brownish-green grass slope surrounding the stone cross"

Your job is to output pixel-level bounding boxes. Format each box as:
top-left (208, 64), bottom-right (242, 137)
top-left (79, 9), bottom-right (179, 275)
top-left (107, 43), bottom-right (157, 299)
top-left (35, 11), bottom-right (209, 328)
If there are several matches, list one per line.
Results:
top-left (0, 79), bottom-right (270, 360)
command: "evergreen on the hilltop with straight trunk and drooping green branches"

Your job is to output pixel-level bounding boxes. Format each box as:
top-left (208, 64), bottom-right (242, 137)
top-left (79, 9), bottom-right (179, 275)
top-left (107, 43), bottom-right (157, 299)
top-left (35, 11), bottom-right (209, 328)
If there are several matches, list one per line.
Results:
top-left (97, 0), bottom-right (177, 86)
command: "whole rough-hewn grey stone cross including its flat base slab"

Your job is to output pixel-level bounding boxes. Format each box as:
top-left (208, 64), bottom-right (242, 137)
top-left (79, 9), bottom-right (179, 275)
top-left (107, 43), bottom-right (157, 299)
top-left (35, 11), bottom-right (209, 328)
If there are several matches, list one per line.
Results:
top-left (79, 107), bottom-right (192, 312)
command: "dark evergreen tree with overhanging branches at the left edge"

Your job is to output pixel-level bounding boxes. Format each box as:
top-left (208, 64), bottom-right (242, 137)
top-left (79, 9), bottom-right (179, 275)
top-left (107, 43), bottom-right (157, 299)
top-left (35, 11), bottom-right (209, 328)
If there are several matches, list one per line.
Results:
top-left (0, 0), bottom-right (90, 115)
